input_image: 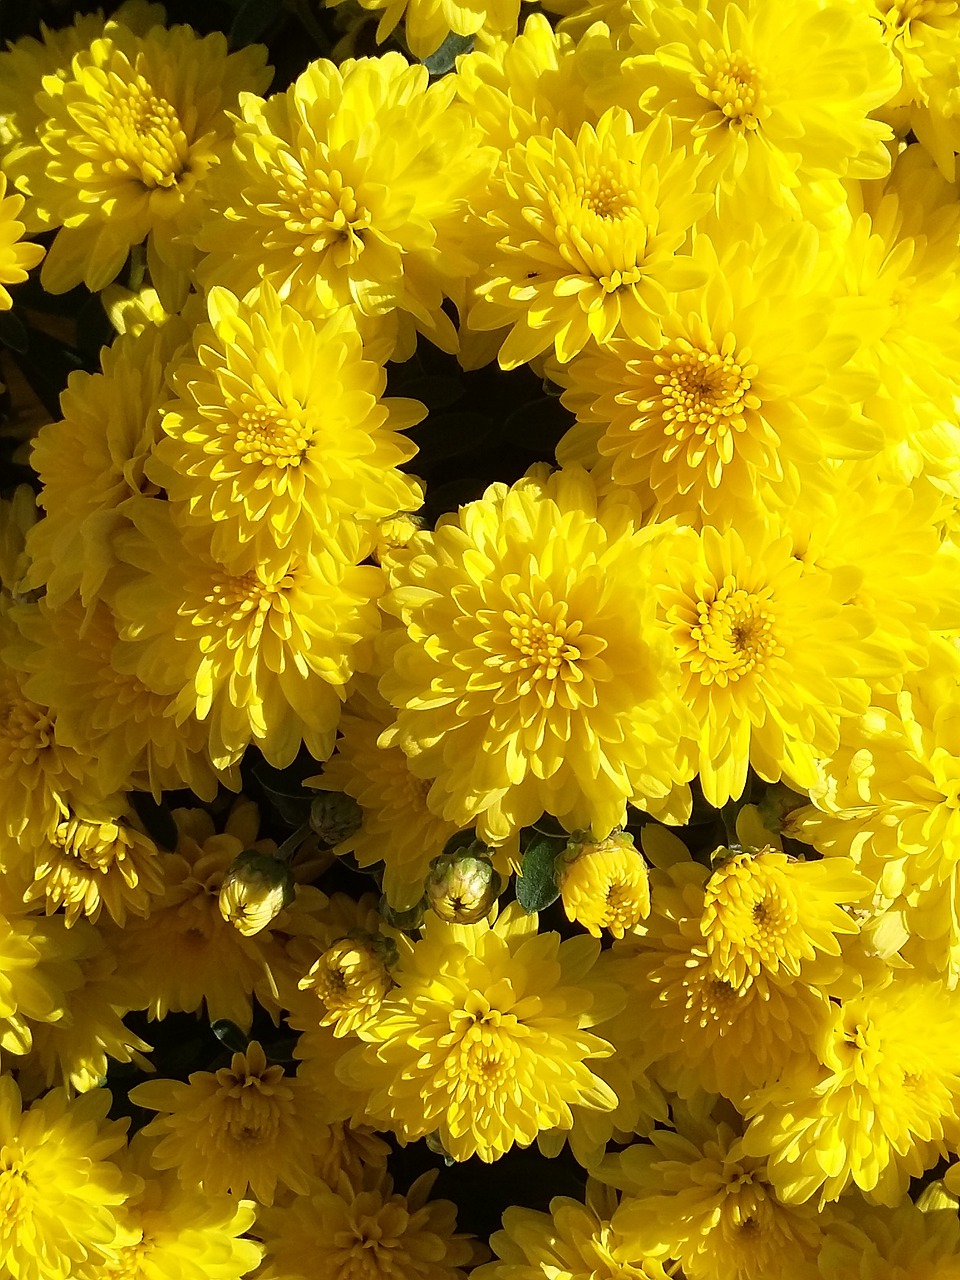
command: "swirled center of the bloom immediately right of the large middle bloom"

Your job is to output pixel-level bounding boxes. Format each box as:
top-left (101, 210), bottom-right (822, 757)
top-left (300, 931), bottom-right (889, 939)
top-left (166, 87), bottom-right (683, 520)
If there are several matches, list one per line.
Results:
top-left (689, 577), bottom-right (783, 685)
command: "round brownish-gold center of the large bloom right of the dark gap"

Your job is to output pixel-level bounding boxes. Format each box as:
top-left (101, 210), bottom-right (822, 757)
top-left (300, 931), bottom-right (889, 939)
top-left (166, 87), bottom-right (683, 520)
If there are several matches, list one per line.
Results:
top-left (654, 338), bottom-right (760, 444)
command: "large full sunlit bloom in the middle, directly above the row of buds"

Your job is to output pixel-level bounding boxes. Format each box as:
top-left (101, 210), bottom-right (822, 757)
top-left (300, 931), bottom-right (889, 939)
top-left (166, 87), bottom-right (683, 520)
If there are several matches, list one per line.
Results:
top-left (380, 467), bottom-right (692, 844)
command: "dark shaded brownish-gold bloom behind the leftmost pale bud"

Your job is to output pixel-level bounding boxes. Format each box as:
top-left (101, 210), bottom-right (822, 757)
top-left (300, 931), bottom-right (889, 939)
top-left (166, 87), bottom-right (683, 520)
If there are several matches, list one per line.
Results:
top-left (109, 800), bottom-right (325, 1027)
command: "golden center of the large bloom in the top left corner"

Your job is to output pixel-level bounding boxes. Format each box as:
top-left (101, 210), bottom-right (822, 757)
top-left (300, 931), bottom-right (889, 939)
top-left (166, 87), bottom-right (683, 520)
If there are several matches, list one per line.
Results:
top-left (105, 76), bottom-right (189, 188)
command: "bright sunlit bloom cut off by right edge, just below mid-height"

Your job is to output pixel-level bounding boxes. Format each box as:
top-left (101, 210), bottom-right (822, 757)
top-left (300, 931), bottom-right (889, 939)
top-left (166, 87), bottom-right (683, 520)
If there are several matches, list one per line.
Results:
top-left (785, 643), bottom-right (960, 984)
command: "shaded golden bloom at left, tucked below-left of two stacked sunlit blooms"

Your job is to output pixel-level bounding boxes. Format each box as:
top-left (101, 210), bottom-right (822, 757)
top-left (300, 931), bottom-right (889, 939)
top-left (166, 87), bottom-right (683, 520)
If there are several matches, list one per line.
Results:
top-left (14, 596), bottom-right (226, 798)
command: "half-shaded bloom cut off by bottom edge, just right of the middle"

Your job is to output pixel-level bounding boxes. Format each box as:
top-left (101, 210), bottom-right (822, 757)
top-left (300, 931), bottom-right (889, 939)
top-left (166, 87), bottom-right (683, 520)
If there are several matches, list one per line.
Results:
top-left (472, 1180), bottom-right (672, 1280)
